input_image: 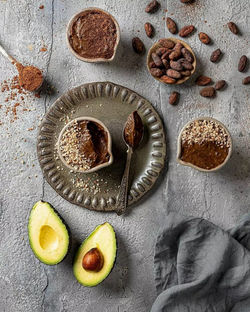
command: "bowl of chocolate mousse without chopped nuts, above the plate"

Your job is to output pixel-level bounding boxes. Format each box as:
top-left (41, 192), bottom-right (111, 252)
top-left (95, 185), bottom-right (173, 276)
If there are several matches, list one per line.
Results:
top-left (67, 7), bottom-right (120, 63)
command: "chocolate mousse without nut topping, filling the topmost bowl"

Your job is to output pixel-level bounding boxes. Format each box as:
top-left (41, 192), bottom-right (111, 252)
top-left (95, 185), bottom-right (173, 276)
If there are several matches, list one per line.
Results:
top-left (69, 10), bottom-right (117, 59)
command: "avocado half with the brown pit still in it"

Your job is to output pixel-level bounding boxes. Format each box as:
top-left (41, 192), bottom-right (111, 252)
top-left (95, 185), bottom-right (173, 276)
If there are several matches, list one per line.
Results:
top-left (73, 222), bottom-right (116, 287)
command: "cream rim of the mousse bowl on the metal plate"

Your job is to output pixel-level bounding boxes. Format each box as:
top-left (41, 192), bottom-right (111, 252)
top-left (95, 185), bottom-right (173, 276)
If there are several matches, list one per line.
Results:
top-left (56, 116), bottom-right (114, 173)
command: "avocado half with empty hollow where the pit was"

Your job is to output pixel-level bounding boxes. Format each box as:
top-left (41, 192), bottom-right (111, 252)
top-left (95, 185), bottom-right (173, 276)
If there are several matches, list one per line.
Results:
top-left (28, 201), bottom-right (69, 265)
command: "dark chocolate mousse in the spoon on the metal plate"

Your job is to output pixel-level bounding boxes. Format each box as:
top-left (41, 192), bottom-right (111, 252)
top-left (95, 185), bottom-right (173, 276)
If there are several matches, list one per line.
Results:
top-left (124, 111), bottom-right (143, 149)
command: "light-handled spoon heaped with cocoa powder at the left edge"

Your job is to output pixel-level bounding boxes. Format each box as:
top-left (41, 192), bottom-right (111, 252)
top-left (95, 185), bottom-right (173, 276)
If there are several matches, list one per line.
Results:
top-left (0, 41), bottom-right (43, 91)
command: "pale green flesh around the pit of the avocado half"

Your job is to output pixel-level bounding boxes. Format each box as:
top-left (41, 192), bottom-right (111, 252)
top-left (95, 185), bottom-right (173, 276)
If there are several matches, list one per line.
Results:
top-left (73, 222), bottom-right (116, 287)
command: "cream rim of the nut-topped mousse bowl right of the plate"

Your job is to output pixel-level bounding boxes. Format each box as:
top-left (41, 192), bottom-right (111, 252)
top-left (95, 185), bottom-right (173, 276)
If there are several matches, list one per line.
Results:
top-left (177, 117), bottom-right (233, 172)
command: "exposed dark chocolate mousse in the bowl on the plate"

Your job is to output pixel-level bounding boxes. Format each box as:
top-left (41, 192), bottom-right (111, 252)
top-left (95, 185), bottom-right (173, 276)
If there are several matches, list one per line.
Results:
top-left (79, 120), bottom-right (110, 168)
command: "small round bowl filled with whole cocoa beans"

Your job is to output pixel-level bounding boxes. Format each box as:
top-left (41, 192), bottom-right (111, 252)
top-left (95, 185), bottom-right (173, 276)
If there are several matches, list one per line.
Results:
top-left (147, 38), bottom-right (196, 84)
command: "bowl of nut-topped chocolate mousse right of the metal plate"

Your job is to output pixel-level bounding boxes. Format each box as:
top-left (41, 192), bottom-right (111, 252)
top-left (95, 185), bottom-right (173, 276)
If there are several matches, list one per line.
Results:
top-left (177, 117), bottom-right (233, 172)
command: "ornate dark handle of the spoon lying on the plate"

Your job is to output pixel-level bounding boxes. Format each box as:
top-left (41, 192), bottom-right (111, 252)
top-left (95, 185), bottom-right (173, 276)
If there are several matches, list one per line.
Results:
top-left (116, 147), bottom-right (133, 216)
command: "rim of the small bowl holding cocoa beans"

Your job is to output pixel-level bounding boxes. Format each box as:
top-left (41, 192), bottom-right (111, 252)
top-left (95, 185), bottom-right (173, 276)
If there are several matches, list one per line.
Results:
top-left (147, 37), bottom-right (197, 86)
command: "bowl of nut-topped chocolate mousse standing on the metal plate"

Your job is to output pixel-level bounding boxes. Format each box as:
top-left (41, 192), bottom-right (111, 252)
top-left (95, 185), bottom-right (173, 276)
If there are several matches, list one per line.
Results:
top-left (56, 117), bottom-right (113, 173)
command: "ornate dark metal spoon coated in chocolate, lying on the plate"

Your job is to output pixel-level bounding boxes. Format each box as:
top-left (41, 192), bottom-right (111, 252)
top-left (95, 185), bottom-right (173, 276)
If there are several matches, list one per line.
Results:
top-left (116, 111), bottom-right (144, 215)
